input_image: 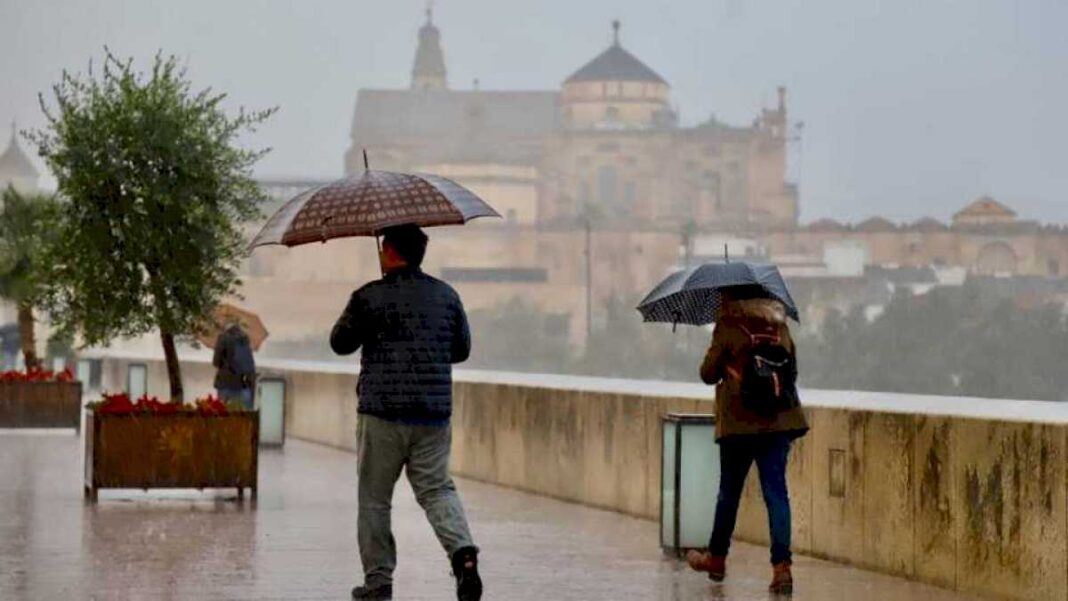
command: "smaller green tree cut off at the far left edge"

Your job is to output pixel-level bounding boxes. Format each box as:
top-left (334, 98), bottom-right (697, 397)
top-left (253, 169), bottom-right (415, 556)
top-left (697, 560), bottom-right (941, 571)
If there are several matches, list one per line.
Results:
top-left (0, 186), bottom-right (60, 369)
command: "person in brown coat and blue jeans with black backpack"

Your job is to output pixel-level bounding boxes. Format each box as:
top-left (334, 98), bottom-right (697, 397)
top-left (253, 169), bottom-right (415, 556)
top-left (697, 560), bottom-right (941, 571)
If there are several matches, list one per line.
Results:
top-left (687, 286), bottom-right (808, 594)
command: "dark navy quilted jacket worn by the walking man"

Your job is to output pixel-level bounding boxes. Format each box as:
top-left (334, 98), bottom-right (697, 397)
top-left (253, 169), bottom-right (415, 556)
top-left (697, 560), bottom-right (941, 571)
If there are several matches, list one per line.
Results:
top-left (330, 268), bottom-right (471, 423)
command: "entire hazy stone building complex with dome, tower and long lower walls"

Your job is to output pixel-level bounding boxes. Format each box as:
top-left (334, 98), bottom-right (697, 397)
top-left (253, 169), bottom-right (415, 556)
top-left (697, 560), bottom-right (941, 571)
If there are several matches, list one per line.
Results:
top-left (245, 14), bottom-right (1068, 345)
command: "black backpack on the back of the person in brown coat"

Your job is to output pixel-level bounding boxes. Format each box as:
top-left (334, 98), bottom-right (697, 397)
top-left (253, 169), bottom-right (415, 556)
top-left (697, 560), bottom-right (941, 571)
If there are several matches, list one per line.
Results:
top-left (741, 327), bottom-right (800, 417)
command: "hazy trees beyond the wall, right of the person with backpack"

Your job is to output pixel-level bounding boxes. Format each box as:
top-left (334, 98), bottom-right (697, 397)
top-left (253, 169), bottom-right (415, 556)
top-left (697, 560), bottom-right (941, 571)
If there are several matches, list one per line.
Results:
top-left (798, 284), bottom-right (1068, 400)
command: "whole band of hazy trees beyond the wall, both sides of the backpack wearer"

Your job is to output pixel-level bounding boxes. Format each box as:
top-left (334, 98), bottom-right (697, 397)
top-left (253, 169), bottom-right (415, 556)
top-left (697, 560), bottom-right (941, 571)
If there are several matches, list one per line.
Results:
top-left (459, 285), bottom-right (1068, 400)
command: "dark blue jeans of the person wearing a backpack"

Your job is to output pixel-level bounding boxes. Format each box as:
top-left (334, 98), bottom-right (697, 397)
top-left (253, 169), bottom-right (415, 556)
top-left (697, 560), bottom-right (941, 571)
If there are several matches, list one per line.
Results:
top-left (708, 433), bottom-right (792, 564)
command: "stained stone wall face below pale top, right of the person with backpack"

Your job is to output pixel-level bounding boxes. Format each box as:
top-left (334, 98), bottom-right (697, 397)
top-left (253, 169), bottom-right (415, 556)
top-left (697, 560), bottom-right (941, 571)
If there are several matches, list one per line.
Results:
top-left (736, 407), bottom-right (1068, 600)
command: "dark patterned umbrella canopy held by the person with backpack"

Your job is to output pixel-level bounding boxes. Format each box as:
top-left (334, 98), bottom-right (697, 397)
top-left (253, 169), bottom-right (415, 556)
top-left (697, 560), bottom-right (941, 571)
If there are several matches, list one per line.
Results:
top-left (638, 263), bottom-right (800, 326)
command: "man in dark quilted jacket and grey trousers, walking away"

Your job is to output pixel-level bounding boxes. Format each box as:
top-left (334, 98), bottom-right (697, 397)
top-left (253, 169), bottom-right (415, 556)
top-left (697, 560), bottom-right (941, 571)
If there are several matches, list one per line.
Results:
top-left (330, 225), bottom-right (482, 601)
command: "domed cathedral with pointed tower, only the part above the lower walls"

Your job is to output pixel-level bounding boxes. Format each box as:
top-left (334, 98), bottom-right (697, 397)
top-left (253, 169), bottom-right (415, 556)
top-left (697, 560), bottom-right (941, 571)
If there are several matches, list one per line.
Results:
top-left (345, 14), bottom-right (798, 231)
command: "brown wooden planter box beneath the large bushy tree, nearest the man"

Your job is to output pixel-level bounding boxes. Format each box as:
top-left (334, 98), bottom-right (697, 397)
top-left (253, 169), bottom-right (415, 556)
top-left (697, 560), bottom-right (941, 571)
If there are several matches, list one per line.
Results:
top-left (85, 411), bottom-right (260, 502)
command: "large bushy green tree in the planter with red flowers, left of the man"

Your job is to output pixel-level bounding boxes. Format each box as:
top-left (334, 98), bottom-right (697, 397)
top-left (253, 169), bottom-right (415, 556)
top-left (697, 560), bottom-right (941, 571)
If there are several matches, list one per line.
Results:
top-left (32, 52), bottom-right (273, 400)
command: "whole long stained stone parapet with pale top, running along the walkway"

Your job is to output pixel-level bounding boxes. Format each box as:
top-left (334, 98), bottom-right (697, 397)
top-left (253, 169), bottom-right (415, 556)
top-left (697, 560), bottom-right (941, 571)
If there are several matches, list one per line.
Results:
top-left (93, 354), bottom-right (1068, 600)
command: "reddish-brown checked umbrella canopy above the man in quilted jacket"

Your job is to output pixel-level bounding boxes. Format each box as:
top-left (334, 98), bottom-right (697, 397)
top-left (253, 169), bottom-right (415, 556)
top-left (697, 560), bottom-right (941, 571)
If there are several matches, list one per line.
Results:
top-left (252, 170), bottom-right (501, 248)
